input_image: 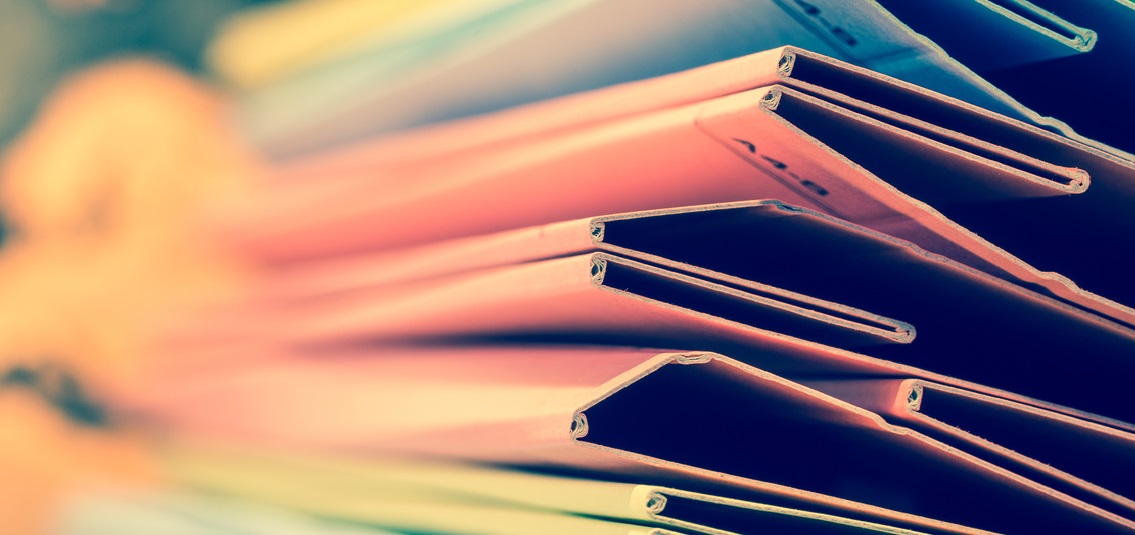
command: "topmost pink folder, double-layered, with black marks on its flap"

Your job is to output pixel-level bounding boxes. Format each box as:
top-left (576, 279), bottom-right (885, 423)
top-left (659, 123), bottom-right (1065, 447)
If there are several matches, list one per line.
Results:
top-left (225, 49), bottom-right (1135, 325)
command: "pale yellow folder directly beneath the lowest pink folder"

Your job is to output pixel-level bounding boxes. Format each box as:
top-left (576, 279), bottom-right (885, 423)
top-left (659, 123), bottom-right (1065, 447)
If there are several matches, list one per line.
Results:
top-left (163, 445), bottom-right (935, 535)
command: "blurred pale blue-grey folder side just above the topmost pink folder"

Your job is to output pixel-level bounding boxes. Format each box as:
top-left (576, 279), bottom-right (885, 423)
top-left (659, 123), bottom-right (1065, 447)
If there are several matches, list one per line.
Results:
top-left (235, 0), bottom-right (834, 157)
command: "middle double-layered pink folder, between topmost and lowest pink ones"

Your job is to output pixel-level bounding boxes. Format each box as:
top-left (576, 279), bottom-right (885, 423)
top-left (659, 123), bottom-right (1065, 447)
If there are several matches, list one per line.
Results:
top-left (181, 201), bottom-right (1135, 428)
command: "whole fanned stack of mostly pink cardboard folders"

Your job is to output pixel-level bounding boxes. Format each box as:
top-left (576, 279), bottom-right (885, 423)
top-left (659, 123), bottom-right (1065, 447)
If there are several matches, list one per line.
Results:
top-left (86, 0), bottom-right (1135, 534)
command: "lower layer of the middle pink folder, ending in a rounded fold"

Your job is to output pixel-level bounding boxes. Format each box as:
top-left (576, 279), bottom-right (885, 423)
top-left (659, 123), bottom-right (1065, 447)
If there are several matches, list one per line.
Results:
top-left (206, 253), bottom-right (911, 361)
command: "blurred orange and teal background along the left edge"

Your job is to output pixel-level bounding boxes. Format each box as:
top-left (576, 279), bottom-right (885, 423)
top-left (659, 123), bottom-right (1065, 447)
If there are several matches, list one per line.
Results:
top-left (0, 0), bottom-right (276, 534)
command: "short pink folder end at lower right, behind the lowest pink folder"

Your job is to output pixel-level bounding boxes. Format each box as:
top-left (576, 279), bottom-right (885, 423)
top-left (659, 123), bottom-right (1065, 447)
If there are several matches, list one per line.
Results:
top-left (807, 379), bottom-right (1135, 518)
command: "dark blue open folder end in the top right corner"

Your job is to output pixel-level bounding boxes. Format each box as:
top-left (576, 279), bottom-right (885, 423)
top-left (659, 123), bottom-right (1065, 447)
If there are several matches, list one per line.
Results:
top-left (776, 0), bottom-right (1135, 152)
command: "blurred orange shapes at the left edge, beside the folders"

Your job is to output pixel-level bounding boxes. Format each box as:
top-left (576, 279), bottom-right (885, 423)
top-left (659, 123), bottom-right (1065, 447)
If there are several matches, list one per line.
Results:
top-left (0, 60), bottom-right (257, 533)
